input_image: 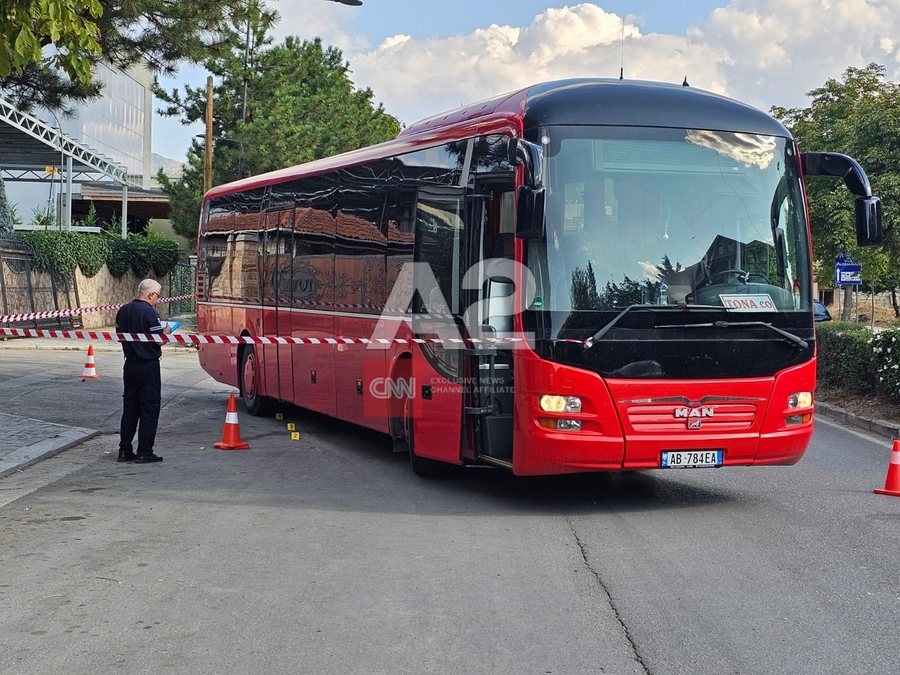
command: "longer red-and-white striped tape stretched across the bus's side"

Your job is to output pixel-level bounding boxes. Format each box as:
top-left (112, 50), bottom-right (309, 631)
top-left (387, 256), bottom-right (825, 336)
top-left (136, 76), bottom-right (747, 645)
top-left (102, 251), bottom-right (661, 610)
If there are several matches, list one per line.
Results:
top-left (0, 328), bottom-right (524, 345)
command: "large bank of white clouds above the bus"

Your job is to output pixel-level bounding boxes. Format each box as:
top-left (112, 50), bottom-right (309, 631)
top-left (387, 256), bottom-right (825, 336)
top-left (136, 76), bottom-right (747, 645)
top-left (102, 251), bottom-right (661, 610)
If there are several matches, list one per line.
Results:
top-left (348, 0), bottom-right (900, 128)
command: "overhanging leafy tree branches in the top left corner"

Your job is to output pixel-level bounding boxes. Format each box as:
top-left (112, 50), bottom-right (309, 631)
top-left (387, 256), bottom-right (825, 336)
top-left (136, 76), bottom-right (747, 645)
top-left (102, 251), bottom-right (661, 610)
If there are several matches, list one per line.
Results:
top-left (0, 0), bottom-right (264, 110)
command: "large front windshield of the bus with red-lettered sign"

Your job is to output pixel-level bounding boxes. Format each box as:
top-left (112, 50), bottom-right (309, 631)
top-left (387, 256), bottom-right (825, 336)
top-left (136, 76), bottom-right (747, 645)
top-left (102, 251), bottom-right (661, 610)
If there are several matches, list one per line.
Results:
top-left (528, 126), bottom-right (812, 323)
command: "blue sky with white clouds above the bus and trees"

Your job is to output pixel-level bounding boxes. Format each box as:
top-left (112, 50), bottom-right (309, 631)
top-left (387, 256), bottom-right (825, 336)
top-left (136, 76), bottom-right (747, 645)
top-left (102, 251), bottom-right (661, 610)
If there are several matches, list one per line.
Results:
top-left (152, 0), bottom-right (900, 160)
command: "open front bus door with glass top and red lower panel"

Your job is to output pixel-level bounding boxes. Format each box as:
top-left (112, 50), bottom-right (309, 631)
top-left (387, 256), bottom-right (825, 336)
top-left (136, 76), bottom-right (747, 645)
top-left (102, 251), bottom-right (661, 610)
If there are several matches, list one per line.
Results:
top-left (412, 187), bottom-right (466, 463)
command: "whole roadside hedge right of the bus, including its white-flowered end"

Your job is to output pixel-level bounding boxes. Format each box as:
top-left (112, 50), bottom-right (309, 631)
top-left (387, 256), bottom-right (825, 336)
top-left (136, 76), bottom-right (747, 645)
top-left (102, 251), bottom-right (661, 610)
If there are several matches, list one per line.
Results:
top-left (816, 322), bottom-right (900, 403)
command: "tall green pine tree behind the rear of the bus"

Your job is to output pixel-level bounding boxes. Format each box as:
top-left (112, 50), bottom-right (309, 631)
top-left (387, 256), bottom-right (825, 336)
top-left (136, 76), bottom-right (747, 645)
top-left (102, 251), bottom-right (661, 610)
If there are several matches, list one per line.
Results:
top-left (156, 18), bottom-right (400, 238)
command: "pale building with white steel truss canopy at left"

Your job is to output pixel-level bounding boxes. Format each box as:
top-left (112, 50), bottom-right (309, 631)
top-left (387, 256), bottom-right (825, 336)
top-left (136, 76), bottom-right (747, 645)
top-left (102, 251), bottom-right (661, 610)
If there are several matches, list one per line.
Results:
top-left (0, 65), bottom-right (168, 235)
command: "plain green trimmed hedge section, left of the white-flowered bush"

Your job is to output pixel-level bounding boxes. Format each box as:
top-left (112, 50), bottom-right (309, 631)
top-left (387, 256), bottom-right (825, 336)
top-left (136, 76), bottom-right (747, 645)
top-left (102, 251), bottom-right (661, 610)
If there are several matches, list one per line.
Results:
top-left (816, 321), bottom-right (876, 394)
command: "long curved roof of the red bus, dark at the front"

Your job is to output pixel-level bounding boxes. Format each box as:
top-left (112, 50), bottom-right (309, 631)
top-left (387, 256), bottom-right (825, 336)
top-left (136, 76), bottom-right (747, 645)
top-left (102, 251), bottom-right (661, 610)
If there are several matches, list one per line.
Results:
top-left (205, 78), bottom-right (790, 199)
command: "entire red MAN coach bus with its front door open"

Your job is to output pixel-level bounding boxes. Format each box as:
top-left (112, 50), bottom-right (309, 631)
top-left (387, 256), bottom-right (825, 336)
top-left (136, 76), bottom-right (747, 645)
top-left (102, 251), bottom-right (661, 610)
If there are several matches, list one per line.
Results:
top-left (197, 79), bottom-right (881, 475)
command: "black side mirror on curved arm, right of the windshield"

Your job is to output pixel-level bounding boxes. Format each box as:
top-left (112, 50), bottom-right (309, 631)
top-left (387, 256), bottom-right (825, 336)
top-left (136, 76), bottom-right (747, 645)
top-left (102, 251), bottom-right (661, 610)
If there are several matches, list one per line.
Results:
top-left (800, 152), bottom-right (884, 246)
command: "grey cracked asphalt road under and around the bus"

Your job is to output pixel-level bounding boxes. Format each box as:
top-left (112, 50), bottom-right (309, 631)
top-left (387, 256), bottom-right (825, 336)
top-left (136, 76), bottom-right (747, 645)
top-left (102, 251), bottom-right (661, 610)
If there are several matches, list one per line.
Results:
top-left (0, 350), bottom-right (900, 674)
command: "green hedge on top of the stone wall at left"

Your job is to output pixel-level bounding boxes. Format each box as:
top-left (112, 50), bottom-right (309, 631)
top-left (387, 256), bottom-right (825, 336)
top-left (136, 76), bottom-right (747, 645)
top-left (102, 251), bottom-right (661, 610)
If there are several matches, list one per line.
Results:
top-left (22, 230), bottom-right (181, 278)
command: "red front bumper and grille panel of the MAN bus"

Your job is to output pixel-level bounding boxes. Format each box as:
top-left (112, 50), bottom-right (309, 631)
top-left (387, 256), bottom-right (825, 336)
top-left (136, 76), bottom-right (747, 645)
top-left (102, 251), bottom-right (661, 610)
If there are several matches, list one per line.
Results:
top-left (513, 350), bottom-right (816, 475)
